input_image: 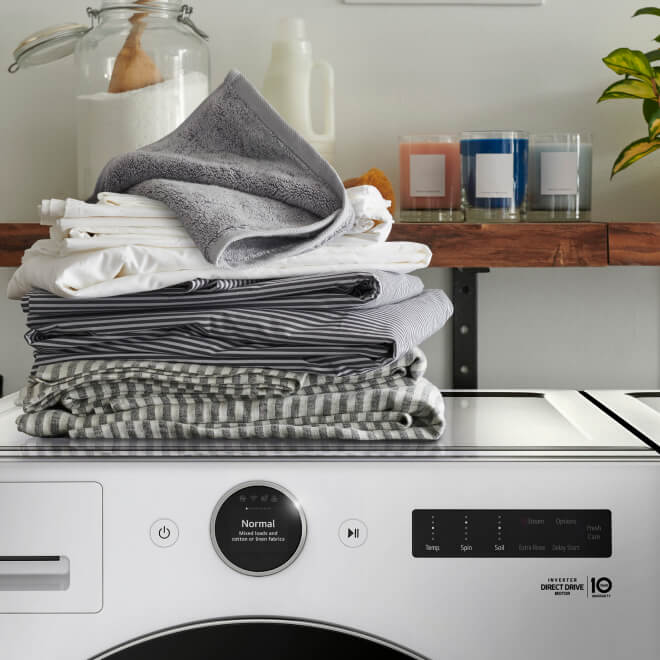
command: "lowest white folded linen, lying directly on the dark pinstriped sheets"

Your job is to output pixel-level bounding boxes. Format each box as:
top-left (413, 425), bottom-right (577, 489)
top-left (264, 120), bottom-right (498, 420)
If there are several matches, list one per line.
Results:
top-left (7, 236), bottom-right (431, 299)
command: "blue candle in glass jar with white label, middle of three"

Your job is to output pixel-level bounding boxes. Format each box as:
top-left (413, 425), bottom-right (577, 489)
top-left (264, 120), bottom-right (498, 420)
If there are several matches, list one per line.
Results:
top-left (461, 131), bottom-right (529, 222)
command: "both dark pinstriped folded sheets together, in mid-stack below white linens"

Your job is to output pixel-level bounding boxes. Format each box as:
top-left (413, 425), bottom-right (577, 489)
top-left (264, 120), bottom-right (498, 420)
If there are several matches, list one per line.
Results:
top-left (23, 273), bottom-right (453, 376)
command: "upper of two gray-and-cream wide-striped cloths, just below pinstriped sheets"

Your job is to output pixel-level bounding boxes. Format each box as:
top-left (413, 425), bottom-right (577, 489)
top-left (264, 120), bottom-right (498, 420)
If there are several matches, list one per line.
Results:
top-left (19, 348), bottom-right (427, 414)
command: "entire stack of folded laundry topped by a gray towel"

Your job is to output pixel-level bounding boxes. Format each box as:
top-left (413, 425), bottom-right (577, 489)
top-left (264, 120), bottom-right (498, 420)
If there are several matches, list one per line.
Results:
top-left (9, 73), bottom-right (452, 441)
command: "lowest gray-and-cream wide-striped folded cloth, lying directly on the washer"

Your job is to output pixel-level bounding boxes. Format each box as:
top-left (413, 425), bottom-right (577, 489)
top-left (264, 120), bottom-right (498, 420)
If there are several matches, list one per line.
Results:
top-left (17, 378), bottom-right (444, 441)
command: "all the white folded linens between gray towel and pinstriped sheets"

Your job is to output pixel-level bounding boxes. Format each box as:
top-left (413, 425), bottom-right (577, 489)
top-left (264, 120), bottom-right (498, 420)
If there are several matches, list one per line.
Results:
top-left (15, 186), bottom-right (412, 299)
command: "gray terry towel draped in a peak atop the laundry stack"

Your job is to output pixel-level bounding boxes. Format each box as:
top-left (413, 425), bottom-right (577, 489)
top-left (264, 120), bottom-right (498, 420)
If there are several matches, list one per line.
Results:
top-left (92, 71), bottom-right (354, 267)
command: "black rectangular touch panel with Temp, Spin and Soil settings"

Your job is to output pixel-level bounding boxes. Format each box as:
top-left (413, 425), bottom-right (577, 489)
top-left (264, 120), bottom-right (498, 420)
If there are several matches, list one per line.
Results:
top-left (412, 509), bottom-right (612, 558)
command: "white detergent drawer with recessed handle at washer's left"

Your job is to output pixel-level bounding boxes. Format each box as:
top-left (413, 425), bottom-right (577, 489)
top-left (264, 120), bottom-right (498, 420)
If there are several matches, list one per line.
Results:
top-left (0, 482), bottom-right (103, 613)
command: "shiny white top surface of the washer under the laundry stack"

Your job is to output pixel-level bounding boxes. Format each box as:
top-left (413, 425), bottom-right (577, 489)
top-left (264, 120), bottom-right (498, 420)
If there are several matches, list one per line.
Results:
top-left (0, 390), bottom-right (660, 460)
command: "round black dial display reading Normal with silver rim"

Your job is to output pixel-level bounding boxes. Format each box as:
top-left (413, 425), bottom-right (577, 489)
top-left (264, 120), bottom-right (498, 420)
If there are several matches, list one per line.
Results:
top-left (211, 481), bottom-right (307, 576)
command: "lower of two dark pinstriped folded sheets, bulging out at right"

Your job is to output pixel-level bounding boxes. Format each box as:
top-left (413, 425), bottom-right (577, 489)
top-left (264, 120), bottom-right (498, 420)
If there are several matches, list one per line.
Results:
top-left (21, 290), bottom-right (453, 375)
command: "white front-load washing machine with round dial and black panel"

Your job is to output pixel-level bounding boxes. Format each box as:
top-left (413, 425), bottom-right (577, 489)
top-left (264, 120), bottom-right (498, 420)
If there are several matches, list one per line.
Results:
top-left (0, 391), bottom-right (660, 660)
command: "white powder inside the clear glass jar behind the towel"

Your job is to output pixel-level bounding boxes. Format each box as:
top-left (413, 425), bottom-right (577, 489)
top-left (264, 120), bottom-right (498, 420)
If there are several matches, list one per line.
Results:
top-left (76, 71), bottom-right (209, 199)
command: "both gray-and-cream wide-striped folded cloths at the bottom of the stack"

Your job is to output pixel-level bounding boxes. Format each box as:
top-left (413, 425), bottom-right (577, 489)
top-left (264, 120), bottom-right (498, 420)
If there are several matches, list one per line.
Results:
top-left (17, 349), bottom-right (444, 441)
